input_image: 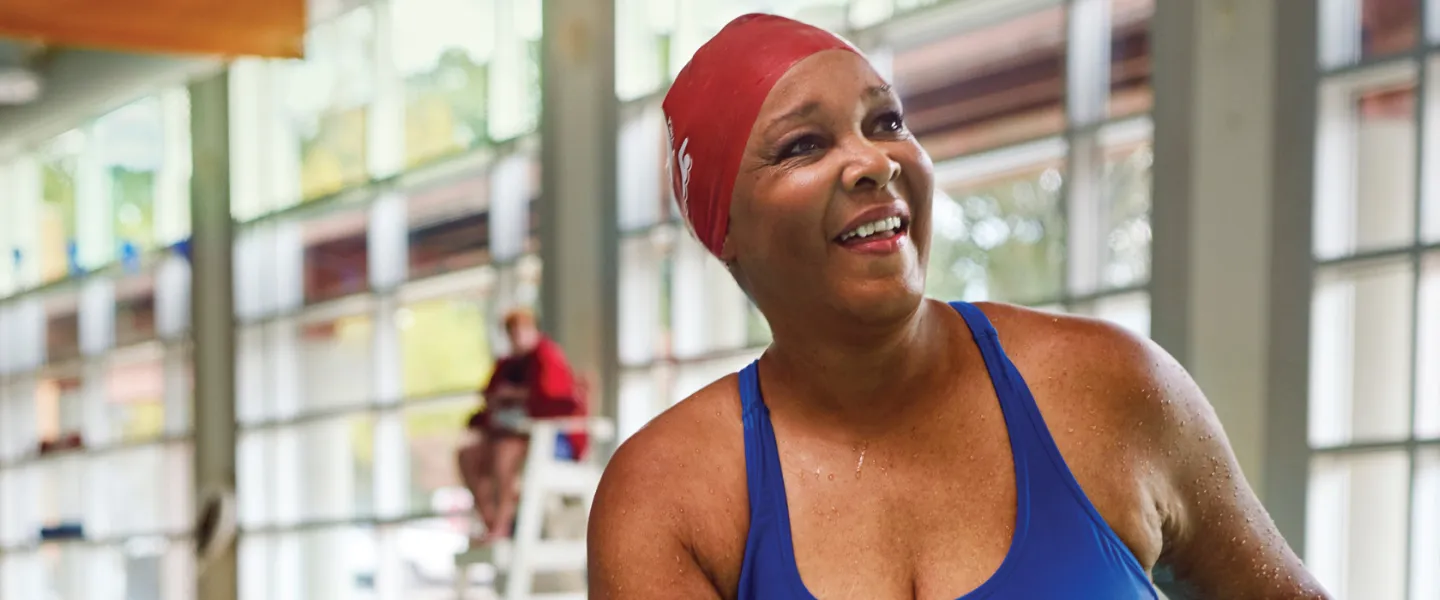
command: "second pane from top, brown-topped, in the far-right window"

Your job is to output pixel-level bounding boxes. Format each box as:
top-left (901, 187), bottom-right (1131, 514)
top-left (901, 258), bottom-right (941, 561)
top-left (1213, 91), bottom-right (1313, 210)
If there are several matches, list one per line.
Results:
top-left (1315, 65), bottom-right (1417, 259)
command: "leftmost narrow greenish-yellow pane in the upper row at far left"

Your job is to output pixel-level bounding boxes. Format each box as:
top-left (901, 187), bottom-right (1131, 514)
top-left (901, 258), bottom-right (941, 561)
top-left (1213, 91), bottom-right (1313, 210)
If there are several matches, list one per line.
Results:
top-left (40, 131), bottom-right (85, 282)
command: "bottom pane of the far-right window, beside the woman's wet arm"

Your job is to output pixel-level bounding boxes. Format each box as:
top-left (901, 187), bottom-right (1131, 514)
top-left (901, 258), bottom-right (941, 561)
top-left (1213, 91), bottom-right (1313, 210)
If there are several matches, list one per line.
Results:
top-left (1305, 452), bottom-right (1410, 599)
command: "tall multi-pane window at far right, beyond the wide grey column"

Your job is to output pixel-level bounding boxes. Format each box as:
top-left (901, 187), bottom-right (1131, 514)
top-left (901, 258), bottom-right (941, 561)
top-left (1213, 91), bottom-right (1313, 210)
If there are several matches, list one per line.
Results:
top-left (1306, 0), bottom-right (1440, 599)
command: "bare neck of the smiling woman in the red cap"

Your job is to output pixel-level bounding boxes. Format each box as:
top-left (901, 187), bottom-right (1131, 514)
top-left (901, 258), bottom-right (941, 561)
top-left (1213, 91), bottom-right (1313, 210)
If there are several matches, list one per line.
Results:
top-left (760, 299), bottom-right (958, 424)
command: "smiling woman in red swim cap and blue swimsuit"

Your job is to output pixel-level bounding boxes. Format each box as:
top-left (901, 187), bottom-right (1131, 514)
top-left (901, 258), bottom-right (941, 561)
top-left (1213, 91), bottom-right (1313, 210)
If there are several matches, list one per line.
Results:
top-left (589, 16), bottom-right (1325, 600)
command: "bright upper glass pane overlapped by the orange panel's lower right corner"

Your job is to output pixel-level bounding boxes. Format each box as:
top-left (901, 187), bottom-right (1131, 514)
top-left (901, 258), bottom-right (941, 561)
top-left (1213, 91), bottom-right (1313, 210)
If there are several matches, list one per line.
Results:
top-left (281, 9), bottom-right (376, 200)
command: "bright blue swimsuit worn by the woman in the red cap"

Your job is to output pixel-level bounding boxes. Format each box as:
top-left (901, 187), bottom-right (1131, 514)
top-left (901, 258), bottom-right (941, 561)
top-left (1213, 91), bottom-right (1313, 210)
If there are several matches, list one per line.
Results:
top-left (739, 302), bottom-right (1156, 600)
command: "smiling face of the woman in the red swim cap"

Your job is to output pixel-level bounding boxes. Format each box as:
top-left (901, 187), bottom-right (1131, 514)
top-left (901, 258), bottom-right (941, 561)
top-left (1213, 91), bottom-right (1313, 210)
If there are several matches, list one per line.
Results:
top-left (721, 50), bottom-right (935, 328)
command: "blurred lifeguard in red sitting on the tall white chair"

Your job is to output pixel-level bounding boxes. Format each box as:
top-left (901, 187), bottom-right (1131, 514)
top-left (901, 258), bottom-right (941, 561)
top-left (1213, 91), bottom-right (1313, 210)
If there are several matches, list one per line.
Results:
top-left (458, 309), bottom-right (589, 544)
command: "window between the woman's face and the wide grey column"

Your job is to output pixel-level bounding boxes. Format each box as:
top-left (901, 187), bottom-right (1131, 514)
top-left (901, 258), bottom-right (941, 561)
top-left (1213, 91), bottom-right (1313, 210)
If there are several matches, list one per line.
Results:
top-left (876, 0), bottom-right (1155, 313)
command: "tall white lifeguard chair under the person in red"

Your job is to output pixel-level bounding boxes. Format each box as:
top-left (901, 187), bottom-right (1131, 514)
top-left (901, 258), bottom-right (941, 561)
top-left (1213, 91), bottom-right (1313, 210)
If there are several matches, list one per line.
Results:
top-left (455, 417), bottom-right (615, 600)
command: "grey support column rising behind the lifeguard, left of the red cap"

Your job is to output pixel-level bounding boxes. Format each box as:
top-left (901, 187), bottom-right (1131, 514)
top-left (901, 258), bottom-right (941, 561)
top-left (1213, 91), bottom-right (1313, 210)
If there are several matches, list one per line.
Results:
top-left (540, 0), bottom-right (619, 440)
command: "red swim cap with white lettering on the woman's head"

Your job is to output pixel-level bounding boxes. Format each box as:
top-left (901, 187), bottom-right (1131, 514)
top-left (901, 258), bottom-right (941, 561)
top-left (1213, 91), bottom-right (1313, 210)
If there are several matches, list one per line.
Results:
top-left (662, 14), bottom-right (860, 256)
